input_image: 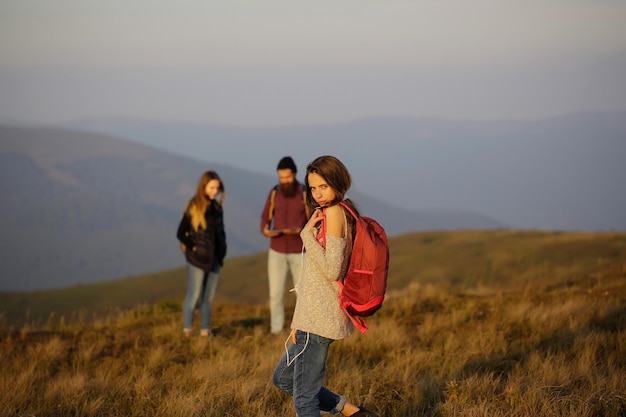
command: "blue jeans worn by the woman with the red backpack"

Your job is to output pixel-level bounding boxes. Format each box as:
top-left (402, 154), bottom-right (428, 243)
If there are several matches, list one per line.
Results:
top-left (272, 330), bottom-right (346, 417)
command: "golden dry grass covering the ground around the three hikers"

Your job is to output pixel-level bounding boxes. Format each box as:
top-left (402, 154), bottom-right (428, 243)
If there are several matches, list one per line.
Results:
top-left (0, 231), bottom-right (626, 417)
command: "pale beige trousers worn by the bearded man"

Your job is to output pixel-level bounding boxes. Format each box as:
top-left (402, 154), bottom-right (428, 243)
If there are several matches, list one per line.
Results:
top-left (267, 249), bottom-right (302, 333)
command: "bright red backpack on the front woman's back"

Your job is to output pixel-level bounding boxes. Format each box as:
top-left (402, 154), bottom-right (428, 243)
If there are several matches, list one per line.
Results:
top-left (322, 202), bottom-right (389, 333)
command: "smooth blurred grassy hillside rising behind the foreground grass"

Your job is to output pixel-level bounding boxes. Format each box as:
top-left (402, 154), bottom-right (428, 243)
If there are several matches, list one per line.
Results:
top-left (0, 231), bottom-right (626, 327)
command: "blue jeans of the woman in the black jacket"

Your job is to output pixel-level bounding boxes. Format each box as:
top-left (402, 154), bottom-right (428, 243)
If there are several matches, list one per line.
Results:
top-left (183, 262), bottom-right (221, 330)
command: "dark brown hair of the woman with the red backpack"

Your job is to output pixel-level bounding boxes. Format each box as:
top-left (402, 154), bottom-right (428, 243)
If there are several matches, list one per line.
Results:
top-left (304, 155), bottom-right (359, 219)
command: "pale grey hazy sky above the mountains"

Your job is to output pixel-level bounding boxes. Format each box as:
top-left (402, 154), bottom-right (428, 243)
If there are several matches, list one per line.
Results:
top-left (0, 0), bottom-right (626, 126)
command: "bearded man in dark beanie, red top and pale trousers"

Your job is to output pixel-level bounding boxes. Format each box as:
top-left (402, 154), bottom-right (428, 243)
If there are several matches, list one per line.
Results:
top-left (261, 156), bottom-right (309, 334)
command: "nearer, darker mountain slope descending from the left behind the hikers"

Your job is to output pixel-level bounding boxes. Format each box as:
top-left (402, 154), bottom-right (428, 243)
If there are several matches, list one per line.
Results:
top-left (0, 126), bottom-right (498, 291)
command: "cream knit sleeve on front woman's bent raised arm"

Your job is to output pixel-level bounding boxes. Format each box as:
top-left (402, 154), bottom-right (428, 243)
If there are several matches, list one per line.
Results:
top-left (300, 228), bottom-right (347, 282)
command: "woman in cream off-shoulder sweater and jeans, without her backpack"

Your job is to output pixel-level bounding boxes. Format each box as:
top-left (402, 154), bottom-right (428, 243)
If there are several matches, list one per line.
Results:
top-left (272, 155), bottom-right (378, 417)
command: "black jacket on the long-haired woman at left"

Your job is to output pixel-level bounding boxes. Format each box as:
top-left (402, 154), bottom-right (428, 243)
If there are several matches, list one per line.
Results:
top-left (176, 200), bottom-right (226, 272)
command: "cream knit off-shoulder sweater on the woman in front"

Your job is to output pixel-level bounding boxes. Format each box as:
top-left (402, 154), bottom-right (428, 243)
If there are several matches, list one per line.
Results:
top-left (291, 213), bottom-right (354, 340)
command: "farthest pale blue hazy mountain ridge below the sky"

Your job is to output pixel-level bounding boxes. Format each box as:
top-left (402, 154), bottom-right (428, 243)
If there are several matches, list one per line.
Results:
top-left (68, 111), bottom-right (626, 231)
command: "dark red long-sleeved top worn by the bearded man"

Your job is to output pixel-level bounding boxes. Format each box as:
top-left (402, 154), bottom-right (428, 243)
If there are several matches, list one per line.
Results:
top-left (261, 183), bottom-right (308, 253)
